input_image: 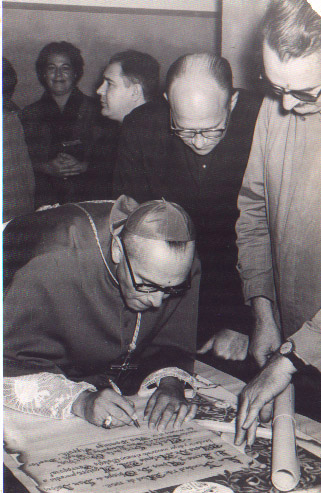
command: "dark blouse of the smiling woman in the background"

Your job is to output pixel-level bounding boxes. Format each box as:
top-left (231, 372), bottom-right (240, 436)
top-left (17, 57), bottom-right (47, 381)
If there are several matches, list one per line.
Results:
top-left (20, 87), bottom-right (118, 206)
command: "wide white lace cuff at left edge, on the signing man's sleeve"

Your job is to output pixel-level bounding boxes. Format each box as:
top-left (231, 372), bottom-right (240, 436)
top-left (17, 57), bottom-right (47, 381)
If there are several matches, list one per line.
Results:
top-left (3, 372), bottom-right (97, 419)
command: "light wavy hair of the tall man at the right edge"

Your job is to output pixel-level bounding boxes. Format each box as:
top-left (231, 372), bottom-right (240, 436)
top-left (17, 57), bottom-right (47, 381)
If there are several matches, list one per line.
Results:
top-left (261, 0), bottom-right (321, 60)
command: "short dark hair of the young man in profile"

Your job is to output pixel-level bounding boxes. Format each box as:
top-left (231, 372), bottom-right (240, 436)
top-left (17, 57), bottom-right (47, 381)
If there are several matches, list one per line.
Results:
top-left (109, 50), bottom-right (159, 101)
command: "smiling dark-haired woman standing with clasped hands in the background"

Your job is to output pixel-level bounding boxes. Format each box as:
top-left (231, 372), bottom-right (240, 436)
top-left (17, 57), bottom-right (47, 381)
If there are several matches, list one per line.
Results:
top-left (20, 41), bottom-right (112, 206)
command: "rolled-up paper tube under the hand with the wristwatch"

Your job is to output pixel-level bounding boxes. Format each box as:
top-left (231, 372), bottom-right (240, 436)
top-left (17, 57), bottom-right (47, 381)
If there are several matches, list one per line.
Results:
top-left (271, 384), bottom-right (300, 491)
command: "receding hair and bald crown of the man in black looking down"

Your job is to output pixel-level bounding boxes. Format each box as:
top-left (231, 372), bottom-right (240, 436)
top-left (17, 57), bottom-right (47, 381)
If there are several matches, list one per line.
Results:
top-left (166, 53), bottom-right (233, 97)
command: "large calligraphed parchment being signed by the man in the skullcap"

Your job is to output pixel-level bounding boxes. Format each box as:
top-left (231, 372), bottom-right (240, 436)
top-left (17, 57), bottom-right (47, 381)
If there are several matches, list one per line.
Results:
top-left (4, 363), bottom-right (320, 493)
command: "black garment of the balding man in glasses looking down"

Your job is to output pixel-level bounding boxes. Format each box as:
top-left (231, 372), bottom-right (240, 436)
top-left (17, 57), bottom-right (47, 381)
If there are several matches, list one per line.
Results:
top-left (113, 89), bottom-right (262, 332)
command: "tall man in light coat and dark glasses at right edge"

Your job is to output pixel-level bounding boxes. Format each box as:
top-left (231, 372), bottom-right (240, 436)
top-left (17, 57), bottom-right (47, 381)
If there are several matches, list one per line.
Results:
top-left (232, 0), bottom-right (321, 444)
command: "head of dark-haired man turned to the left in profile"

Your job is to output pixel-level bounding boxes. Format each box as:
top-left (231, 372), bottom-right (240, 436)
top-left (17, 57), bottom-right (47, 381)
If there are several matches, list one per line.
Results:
top-left (97, 50), bottom-right (159, 123)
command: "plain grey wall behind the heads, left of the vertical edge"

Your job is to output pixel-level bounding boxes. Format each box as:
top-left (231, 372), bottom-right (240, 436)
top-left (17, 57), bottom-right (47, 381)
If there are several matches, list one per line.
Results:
top-left (3, 2), bottom-right (221, 107)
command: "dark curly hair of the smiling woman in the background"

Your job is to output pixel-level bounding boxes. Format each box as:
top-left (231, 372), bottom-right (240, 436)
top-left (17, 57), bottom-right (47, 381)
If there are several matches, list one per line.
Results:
top-left (36, 41), bottom-right (84, 87)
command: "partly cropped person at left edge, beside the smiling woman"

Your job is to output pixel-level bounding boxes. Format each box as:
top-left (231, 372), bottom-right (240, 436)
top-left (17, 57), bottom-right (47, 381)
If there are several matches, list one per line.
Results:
top-left (2, 57), bottom-right (35, 222)
